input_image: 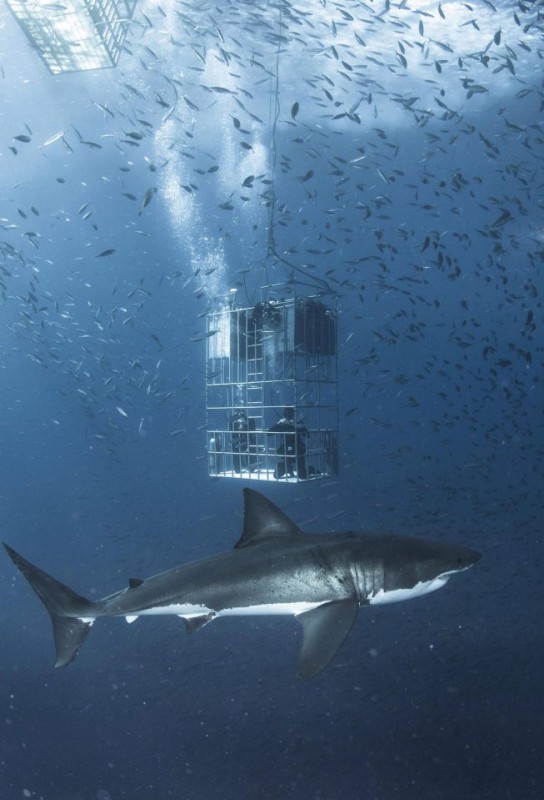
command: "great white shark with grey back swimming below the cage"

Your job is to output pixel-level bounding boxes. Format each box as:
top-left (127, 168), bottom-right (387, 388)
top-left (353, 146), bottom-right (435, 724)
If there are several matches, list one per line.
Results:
top-left (4, 489), bottom-right (480, 680)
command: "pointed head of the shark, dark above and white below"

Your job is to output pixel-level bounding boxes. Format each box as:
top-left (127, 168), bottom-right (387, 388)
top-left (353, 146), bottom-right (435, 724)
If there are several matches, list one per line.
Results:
top-left (356, 535), bottom-right (480, 604)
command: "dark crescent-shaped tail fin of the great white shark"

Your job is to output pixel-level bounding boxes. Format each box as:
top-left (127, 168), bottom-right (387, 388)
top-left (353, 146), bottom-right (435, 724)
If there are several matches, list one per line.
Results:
top-left (4, 544), bottom-right (95, 667)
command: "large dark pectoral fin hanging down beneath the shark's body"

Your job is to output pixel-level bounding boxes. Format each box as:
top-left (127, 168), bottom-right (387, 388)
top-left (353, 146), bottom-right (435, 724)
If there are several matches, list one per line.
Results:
top-left (297, 599), bottom-right (359, 681)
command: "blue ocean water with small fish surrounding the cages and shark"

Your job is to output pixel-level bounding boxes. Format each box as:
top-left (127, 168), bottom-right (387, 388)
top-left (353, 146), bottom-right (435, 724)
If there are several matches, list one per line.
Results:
top-left (0, 0), bottom-right (544, 800)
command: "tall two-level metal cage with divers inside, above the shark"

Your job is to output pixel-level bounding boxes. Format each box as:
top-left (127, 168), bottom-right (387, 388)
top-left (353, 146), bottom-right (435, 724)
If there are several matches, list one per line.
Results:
top-left (206, 286), bottom-right (338, 483)
